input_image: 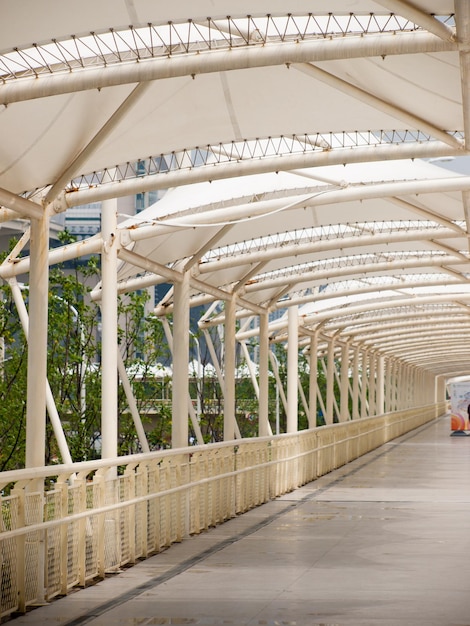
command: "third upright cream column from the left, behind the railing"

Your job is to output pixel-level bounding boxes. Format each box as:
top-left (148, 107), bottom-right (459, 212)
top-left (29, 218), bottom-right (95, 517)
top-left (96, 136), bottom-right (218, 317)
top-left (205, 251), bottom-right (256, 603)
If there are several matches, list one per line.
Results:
top-left (171, 272), bottom-right (189, 448)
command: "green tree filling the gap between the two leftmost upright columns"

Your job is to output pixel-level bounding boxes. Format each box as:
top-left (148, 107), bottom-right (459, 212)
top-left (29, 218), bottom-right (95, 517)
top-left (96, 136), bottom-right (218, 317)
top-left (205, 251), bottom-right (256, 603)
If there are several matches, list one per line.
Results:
top-left (46, 249), bottom-right (101, 463)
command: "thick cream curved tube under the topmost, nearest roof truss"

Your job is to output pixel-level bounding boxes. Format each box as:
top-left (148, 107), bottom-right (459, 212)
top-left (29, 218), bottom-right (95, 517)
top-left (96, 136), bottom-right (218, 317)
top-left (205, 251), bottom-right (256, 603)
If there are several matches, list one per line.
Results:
top-left (0, 33), bottom-right (458, 106)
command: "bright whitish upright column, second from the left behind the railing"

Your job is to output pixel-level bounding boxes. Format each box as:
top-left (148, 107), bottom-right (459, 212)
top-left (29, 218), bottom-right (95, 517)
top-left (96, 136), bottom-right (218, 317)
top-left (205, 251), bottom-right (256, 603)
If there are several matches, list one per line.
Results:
top-left (101, 199), bottom-right (118, 459)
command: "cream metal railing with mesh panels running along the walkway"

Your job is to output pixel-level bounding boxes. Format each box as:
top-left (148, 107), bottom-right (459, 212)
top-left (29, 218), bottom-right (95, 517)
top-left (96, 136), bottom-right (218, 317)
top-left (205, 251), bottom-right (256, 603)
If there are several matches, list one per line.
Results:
top-left (0, 403), bottom-right (447, 617)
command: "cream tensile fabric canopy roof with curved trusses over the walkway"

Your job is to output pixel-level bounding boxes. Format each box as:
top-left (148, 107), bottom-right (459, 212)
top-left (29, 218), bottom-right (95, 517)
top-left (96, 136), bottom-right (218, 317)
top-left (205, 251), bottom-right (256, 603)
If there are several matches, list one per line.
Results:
top-left (0, 0), bottom-right (470, 377)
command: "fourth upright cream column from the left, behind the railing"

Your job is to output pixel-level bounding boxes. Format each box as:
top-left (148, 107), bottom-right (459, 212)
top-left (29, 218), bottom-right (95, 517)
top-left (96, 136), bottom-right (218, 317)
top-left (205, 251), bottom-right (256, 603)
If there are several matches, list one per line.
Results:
top-left (224, 298), bottom-right (236, 441)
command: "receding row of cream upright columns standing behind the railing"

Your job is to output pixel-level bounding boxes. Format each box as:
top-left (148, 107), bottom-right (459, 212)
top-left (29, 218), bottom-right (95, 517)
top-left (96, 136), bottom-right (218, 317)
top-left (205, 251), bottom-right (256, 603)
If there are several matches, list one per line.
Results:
top-left (19, 200), bottom-right (445, 467)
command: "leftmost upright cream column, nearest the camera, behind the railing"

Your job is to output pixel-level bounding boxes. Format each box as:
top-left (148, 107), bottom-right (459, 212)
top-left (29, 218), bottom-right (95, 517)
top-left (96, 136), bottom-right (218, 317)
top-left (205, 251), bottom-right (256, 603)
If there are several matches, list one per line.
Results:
top-left (25, 211), bottom-right (49, 468)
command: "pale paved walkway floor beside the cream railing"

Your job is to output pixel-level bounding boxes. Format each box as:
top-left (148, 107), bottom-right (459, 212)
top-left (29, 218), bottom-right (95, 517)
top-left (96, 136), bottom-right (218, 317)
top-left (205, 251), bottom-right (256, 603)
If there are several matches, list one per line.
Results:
top-left (10, 416), bottom-right (470, 626)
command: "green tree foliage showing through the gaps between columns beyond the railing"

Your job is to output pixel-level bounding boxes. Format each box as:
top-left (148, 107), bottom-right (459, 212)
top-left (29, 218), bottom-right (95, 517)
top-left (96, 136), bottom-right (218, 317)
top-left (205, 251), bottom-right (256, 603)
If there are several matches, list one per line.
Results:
top-left (0, 232), bottom-right (334, 471)
